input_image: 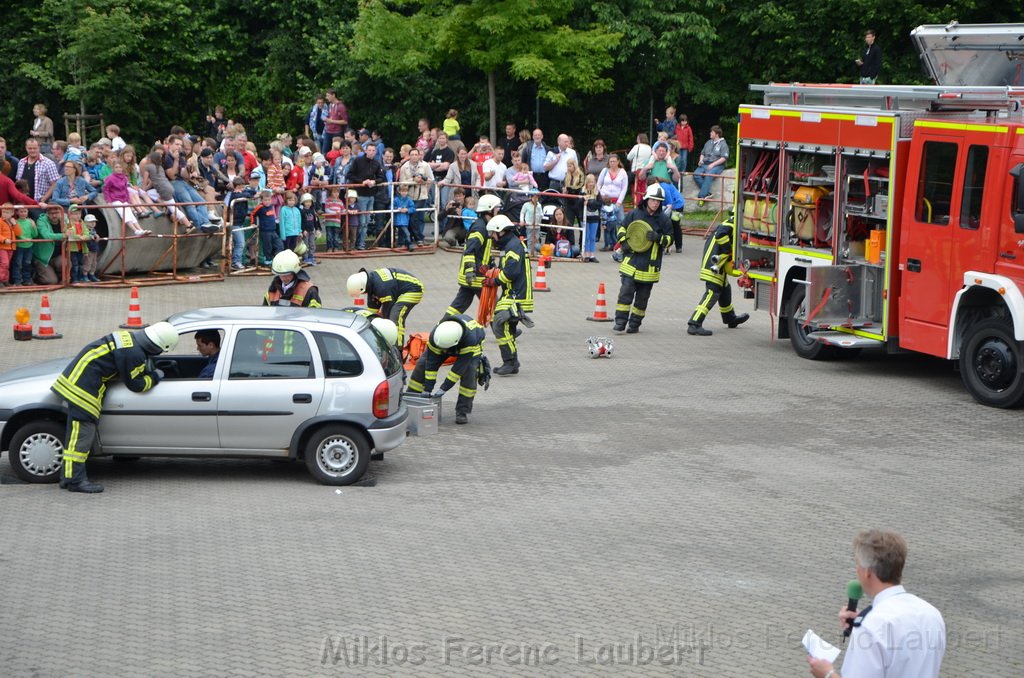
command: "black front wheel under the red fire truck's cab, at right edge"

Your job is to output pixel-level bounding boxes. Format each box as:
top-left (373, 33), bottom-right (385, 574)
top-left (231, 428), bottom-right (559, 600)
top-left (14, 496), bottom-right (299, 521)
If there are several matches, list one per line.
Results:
top-left (959, 320), bottom-right (1024, 408)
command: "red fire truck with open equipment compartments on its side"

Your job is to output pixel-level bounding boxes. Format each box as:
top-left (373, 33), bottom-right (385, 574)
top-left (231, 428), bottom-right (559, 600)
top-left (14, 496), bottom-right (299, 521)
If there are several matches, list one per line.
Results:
top-left (734, 24), bottom-right (1024, 408)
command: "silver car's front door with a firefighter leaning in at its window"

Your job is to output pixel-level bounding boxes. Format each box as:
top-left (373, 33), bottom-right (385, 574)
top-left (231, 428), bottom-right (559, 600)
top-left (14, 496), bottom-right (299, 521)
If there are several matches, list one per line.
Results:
top-left (99, 333), bottom-right (220, 455)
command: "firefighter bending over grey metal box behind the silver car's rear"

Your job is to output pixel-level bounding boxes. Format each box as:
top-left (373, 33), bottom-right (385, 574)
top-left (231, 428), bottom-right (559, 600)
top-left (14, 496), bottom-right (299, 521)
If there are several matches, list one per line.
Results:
top-left (409, 313), bottom-right (489, 424)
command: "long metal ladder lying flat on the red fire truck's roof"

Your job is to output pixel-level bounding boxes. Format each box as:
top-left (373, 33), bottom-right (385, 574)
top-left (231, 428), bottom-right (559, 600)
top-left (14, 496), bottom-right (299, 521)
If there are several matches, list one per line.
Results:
top-left (751, 83), bottom-right (1024, 117)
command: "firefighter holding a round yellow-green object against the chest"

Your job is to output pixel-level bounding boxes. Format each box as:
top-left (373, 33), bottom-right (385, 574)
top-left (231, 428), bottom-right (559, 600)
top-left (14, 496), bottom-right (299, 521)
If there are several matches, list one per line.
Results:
top-left (611, 183), bottom-right (672, 334)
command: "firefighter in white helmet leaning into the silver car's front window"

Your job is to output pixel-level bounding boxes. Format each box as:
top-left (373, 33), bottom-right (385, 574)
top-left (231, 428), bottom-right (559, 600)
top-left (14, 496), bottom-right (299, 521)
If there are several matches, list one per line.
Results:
top-left (50, 323), bottom-right (178, 494)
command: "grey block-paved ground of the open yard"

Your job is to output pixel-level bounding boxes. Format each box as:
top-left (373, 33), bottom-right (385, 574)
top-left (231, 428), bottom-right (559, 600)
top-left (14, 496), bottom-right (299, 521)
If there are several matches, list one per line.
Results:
top-left (0, 238), bottom-right (1024, 676)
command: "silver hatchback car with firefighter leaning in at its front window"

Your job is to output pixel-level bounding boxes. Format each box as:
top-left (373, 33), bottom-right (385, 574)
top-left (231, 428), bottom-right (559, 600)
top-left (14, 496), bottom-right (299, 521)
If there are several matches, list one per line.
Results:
top-left (0, 306), bottom-right (409, 485)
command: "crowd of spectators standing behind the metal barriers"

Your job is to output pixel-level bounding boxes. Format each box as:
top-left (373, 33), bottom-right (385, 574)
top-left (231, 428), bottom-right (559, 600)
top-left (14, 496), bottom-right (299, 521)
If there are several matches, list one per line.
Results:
top-left (0, 94), bottom-right (728, 286)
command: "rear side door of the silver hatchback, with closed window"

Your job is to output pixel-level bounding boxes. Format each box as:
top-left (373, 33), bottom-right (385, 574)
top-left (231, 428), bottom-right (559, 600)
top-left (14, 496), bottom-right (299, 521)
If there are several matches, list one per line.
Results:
top-left (217, 326), bottom-right (324, 456)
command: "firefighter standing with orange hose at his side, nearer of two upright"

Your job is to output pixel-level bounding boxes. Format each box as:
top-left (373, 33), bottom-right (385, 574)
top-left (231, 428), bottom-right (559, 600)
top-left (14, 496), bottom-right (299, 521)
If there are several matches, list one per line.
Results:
top-left (484, 214), bottom-right (534, 377)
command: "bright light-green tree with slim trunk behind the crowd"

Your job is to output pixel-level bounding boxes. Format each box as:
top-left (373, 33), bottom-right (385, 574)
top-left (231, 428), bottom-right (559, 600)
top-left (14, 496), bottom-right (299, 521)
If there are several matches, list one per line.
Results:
top-left (353, 0), bottom-right (622, 138)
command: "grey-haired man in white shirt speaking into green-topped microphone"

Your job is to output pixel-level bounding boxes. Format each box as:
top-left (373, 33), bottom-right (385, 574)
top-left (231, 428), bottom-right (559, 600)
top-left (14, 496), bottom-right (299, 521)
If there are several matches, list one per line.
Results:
top-left (807, 529), bottom-right (946, 678)
